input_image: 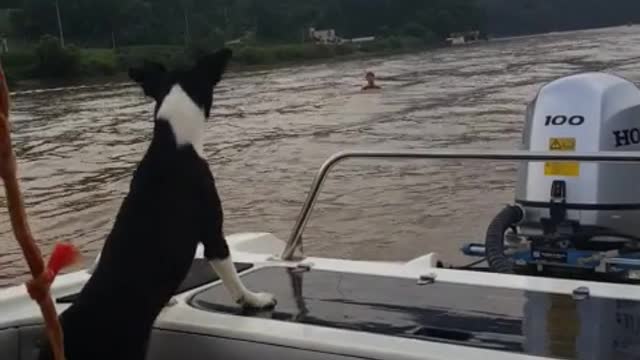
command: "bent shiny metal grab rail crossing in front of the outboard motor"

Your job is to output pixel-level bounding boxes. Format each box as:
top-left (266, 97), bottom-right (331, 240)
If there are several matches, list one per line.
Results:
top-left (281, 150), bottom-right (640, 261)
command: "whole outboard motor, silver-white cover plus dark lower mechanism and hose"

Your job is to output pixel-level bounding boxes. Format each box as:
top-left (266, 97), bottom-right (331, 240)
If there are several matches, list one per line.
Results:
top-left (467, 73), bottom-right (640, 280)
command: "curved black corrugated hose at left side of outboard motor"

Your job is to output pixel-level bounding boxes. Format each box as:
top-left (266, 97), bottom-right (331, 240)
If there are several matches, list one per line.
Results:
top-left (485, 205), bottom-right (524, 274)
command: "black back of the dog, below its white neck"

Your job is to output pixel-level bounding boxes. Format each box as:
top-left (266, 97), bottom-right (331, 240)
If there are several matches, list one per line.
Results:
top-left (39, 122), bottom-right (222, 360)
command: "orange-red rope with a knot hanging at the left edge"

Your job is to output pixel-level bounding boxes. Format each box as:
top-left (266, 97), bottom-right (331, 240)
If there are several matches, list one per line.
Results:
top-left (0, 58), bottom-right (77, 360)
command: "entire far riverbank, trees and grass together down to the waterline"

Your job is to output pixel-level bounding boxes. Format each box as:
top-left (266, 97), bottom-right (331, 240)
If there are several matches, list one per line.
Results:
top-left (0, 0), bottom-right (640, 79)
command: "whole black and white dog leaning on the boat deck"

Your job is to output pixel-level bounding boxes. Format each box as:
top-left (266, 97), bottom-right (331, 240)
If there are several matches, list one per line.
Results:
top-left (41, 49), bottom-right (276, 360)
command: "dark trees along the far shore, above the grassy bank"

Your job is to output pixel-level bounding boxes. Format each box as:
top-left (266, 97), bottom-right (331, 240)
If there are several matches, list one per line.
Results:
top-left (5, 0), bottom-right (640, 47)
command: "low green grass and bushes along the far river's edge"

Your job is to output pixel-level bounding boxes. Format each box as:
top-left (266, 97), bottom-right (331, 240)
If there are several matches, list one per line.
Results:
top-left (0, 37), bottom-right (434, 84)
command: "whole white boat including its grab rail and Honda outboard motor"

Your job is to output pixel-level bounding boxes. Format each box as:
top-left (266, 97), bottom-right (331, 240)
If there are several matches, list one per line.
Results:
top-left (0, 73), bottom-right (640, 360)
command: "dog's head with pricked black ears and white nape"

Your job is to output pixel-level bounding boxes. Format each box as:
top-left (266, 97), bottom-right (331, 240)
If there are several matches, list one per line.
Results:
top-left (129, 49), bottom-right (232, 149)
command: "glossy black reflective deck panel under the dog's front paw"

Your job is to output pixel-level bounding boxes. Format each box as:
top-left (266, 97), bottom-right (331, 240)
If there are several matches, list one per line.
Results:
top-left (191, 267), bottom-right (640, 359)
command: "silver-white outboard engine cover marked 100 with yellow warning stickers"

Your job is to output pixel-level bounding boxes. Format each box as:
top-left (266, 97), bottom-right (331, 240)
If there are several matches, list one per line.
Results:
top-left (516, 73), bottom-right (640, 241)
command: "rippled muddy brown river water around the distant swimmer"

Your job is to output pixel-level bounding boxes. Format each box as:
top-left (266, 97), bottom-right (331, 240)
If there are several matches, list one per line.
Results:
top-left (0, 27), bottom-right (640, 286)
